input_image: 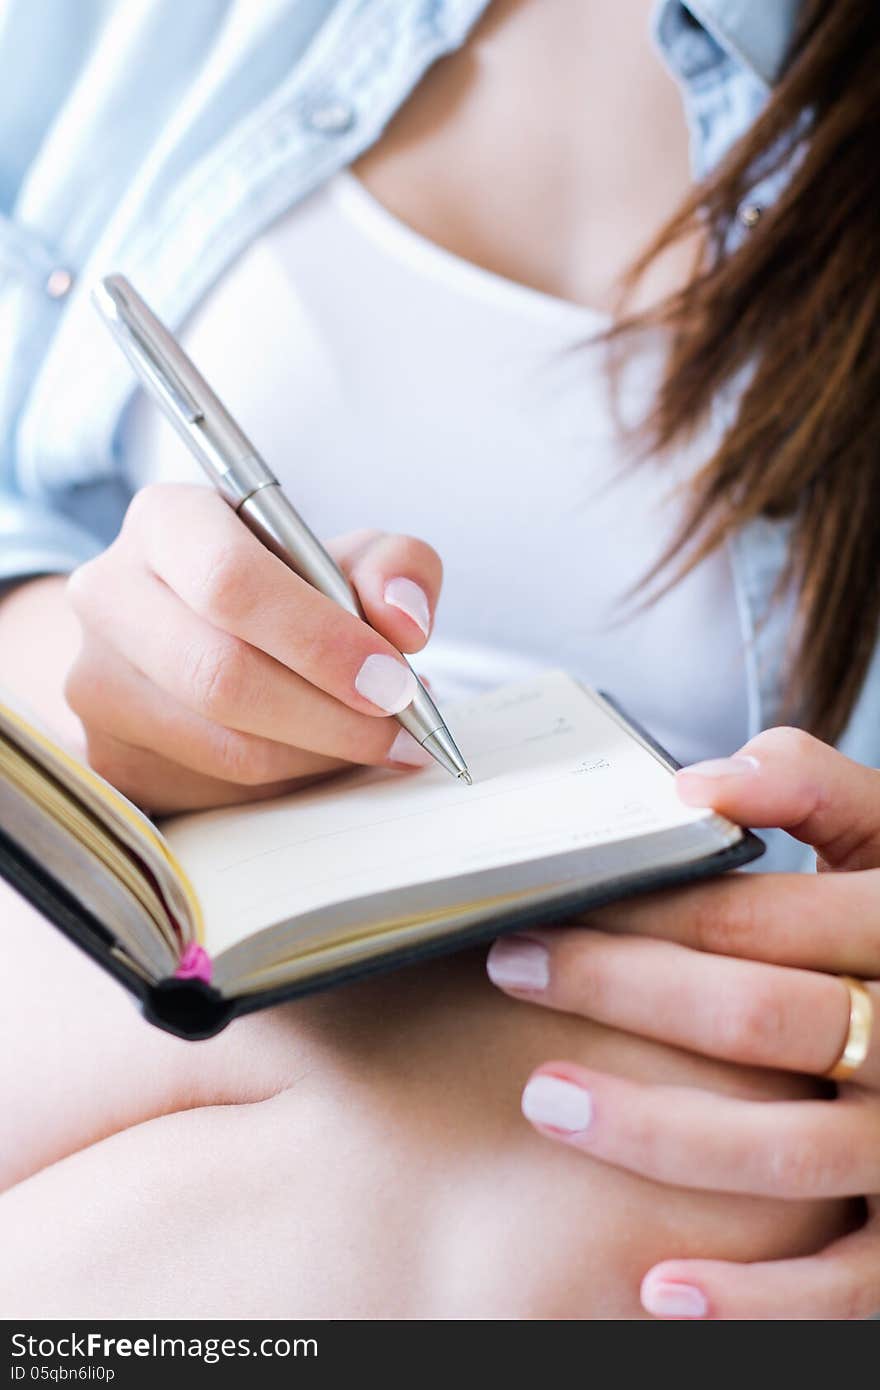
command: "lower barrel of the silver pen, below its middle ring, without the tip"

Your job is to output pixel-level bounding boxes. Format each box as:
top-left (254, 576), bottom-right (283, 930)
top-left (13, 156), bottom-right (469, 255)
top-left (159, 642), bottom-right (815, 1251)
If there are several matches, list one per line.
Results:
top-left (236, 482), bottom-right (445, 744)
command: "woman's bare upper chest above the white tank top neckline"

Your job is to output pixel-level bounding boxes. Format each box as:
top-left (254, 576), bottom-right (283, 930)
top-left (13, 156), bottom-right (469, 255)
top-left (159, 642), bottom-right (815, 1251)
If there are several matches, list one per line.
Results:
top-left (355, 0), bottom-right (696, 313)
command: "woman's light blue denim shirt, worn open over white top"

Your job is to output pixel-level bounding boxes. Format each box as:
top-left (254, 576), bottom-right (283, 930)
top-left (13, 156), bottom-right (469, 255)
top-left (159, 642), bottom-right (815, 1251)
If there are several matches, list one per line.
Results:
top-left (0, 0), bottom-right (880, 867)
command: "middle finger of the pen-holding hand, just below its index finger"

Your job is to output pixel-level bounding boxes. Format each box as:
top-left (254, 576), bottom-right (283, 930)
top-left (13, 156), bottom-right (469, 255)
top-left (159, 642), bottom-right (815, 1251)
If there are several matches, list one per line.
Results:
top-left (72, 562), bottom-right (416, 763)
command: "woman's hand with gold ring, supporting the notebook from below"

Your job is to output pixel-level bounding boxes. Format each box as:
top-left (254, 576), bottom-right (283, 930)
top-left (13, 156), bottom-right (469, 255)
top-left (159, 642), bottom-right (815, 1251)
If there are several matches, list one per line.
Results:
top-left (488, 728), bottom-right (880, 1319)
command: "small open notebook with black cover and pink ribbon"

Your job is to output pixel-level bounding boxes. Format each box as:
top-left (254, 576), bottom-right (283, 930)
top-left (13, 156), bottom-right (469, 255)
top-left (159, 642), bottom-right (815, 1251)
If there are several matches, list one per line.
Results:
top-left (0, 671), bottom-right (762, 1037)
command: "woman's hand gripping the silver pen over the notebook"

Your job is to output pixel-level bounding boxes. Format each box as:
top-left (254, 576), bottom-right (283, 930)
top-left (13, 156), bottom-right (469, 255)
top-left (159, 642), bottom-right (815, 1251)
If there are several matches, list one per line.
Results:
top-left (65, 484), bottom-right (442, 813)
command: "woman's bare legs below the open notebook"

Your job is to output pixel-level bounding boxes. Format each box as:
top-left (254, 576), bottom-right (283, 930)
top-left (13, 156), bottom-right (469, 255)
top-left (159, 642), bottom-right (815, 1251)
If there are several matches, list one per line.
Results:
top-left (0, 894), bottom-right (845, 1318)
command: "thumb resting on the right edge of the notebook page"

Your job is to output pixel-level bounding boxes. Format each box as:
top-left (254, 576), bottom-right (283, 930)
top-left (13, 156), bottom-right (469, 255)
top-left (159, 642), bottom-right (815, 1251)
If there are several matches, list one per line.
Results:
top-left (676, 728), bottom-right (880, 869)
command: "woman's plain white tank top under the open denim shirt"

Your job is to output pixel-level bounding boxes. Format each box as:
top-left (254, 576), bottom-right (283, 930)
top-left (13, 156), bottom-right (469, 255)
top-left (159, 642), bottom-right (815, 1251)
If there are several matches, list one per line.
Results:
top-left (121, 172), bottom-right (747, 762)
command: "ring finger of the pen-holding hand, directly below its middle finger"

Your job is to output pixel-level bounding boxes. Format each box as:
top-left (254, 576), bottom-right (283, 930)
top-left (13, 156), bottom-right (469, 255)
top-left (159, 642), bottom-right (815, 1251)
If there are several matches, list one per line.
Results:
top-left (64, 635), bottom-right (343, 787)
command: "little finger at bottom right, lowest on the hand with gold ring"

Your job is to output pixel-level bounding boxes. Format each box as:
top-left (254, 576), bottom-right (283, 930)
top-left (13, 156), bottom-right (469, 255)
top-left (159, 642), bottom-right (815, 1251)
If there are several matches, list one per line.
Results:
top-left (641, 1202), bottom-right (880, 1322)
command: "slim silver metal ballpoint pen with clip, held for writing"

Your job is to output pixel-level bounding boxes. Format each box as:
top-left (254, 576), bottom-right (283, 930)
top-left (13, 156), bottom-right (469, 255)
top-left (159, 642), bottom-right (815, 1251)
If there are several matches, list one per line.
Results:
top-left (92, 275), bottom-right (471, 787)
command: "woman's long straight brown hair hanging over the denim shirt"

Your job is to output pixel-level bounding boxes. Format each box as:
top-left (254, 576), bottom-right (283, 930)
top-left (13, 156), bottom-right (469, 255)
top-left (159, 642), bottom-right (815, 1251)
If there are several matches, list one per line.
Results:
top-left (613, 0), bottom-right (880, 741)
